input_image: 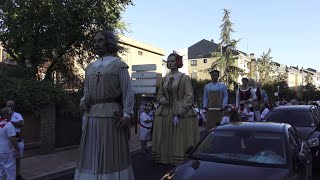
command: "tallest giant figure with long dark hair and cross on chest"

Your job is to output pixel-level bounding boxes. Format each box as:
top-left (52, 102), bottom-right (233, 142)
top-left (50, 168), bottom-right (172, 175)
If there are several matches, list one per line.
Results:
top-left (74, 30), bottom-right (134, 180)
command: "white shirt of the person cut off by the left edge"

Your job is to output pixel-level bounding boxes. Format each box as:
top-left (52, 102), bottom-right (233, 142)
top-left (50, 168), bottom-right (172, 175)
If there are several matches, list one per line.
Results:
top-left (0, 122), bottom-right (17, 153)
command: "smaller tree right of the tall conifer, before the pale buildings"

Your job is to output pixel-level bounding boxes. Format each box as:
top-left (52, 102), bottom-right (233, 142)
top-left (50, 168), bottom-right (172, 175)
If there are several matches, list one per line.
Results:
top-left (257, 49), bottom-right (274, 84)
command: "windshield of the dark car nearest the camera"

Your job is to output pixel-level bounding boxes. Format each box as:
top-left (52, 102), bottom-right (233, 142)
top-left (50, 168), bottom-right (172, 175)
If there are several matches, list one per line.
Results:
top-left (191, 130), bottom-right (286, 167)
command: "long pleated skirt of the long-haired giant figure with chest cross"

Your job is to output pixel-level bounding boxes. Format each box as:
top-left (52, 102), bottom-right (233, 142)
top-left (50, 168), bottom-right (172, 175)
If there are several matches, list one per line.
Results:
top-left (74, 117), bottom-right (134, 180)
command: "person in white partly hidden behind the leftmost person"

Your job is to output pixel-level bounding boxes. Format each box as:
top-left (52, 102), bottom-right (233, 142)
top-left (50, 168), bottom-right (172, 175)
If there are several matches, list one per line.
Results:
top-left (6, 100), bottom-right (24, 180)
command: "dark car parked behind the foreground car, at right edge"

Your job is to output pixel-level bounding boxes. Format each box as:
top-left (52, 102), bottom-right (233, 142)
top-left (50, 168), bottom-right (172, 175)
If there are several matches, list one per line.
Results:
top-left (265, 105), bottom-right (320, 161)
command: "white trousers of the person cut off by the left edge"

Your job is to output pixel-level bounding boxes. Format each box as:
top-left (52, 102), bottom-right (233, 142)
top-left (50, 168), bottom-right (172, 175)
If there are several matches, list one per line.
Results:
top-left (0, 152), bottom-right (16, 180)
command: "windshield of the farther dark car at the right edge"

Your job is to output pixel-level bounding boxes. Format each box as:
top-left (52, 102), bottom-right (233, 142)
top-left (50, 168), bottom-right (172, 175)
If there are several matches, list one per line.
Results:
top-left (266, 111), bottom-right (315, 127)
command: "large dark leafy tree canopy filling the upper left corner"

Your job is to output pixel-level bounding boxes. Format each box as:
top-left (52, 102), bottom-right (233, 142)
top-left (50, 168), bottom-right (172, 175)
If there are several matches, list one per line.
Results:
top-left (0, 0), bottom-right (132, 79)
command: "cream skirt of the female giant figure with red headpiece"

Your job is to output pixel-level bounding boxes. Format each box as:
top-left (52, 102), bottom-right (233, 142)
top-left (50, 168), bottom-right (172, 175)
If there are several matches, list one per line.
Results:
top-left (152, 103), bottom-right (200, 165)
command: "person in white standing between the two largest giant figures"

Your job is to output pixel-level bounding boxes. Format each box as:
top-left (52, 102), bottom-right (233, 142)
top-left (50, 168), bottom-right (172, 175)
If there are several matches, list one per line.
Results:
top-left (140, 106), bottom-right (153, 153)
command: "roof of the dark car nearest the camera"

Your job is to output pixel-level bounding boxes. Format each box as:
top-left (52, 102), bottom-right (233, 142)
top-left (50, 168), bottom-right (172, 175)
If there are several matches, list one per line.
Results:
top-left (215, 122), bottom-right (291, 133)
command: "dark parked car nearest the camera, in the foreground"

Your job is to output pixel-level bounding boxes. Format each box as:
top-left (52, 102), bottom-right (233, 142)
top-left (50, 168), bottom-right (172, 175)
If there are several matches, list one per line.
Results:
top-left (162, 122), bottom-right (312, 180)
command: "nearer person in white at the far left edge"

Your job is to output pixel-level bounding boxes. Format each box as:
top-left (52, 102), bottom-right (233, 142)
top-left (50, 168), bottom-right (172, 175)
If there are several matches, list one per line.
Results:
top-left (0, 108), bottom-right (19, 180)
